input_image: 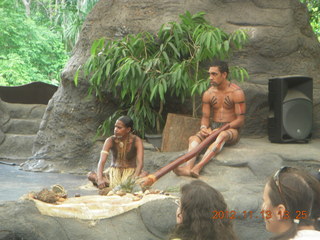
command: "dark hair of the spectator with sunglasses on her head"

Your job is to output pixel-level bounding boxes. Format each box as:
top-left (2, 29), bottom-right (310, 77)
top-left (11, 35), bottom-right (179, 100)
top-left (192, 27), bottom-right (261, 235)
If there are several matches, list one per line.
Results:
top-left (268, 168), bottom-right (320, 240)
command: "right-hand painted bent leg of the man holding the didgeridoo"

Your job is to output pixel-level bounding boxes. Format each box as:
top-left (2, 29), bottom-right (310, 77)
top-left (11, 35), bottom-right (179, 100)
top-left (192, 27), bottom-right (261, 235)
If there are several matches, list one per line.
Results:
top-left (190, 129), bottom-right (238, 178)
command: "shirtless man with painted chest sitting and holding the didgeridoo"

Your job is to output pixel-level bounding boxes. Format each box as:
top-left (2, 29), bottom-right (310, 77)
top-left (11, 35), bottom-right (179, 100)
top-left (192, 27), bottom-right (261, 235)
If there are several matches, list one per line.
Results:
top-left (173, 61), bottom-right (246, 178)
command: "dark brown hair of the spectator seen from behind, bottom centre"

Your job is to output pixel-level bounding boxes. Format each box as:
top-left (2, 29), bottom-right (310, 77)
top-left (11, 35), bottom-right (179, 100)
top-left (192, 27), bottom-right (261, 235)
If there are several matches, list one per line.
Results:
top-left (170, 180), bottom-right (237, 240)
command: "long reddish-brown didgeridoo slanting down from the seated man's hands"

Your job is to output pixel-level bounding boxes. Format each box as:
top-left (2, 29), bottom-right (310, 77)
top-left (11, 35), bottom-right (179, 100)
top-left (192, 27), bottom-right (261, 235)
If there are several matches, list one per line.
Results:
top-left (140, 123), bottom-right (230, 187)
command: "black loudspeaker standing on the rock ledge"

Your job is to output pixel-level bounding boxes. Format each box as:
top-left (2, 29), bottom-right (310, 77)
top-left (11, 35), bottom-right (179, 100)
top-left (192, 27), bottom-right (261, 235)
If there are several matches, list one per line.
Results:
top-left (268, 76), bottom-right (313, 143)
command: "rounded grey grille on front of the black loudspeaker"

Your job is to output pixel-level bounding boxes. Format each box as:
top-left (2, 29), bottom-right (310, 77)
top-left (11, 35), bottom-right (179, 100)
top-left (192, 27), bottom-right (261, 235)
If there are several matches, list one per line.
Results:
top-left (283, 99), bottom-right (312, 140)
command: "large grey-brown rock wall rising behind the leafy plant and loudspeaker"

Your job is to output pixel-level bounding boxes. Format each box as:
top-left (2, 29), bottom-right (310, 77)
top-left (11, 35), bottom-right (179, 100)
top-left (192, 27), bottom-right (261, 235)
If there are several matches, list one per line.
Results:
top-left (25, 0), bottom-right (320, 170)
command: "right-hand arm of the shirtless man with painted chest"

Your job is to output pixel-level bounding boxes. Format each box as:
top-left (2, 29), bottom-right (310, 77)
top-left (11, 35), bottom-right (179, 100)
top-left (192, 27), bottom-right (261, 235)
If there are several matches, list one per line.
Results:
top-left (230, 89), bottom-right (246, 128)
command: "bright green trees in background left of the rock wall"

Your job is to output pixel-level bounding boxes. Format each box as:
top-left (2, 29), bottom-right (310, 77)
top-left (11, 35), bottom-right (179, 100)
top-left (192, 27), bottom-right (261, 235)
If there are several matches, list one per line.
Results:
top-left (0, 0), bottom-right (98, 86)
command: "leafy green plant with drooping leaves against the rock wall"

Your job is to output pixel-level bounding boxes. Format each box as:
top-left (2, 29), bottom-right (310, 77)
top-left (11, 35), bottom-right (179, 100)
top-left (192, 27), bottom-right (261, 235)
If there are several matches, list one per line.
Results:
top-left (80, 12), bottom-right (248, 135)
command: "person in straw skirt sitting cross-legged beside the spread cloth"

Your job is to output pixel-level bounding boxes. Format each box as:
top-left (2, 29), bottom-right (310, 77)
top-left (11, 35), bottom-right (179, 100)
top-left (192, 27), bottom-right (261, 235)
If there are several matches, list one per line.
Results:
top-left (88, 116), bottom-right (146, 189)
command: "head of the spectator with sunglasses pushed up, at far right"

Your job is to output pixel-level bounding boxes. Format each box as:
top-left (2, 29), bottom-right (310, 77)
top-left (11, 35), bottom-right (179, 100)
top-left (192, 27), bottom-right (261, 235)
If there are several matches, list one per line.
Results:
top-left (262, 167), bottom-right (320, 239)
